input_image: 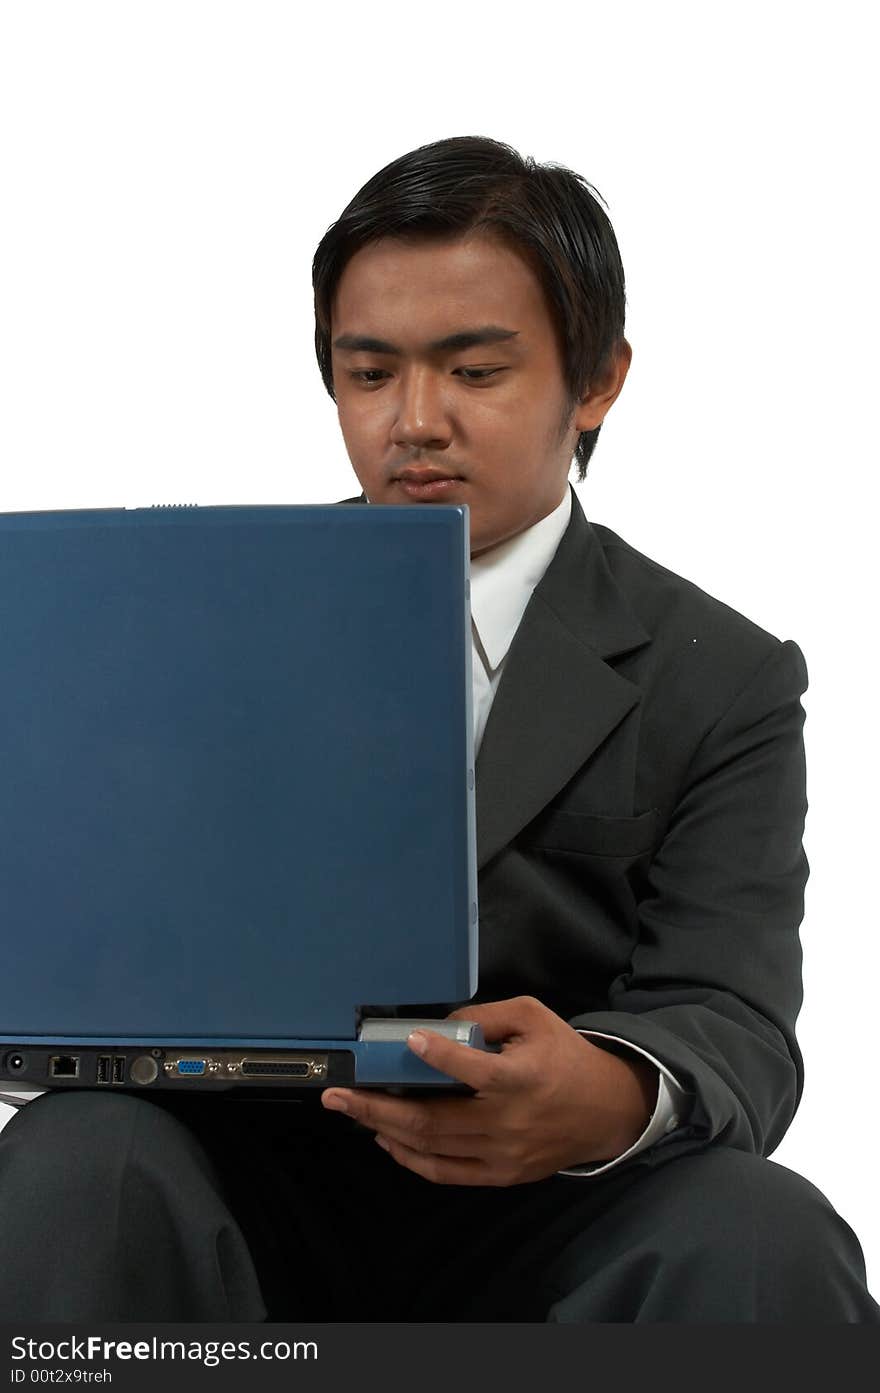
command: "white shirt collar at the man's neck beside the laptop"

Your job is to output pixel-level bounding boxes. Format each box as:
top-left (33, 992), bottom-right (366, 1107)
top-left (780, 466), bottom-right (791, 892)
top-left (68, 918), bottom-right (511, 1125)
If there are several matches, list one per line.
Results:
top-left (471, 488), bottom-right (571, 671)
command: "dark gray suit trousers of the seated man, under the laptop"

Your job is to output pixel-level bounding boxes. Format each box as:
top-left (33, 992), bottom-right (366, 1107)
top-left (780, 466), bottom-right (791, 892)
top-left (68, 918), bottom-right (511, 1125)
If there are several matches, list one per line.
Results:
top-left (0, 1092), bottom-right (880, 1323)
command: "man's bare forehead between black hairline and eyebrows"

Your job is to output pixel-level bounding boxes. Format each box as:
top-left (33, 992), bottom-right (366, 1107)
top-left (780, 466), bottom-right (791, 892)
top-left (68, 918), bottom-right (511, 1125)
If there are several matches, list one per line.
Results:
top-left (331, 233), bottom-right (550, 343)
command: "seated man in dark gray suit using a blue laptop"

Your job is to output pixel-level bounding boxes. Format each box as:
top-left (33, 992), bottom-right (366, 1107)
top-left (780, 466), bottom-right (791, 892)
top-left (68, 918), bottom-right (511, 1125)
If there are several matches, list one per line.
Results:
top-left (0, 130), bottom-right (880, 1322)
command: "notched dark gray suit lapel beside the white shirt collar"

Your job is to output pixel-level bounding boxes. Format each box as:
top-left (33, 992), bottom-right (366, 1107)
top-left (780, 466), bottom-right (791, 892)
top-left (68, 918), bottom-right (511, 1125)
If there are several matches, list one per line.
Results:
top-left (476, 490), bottom-right (650, 866)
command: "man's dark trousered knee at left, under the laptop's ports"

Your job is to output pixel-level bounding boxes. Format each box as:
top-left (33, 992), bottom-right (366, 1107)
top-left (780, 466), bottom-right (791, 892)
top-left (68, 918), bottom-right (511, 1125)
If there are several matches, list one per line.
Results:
top-left (0, 1091), bottom-right (265, 1321)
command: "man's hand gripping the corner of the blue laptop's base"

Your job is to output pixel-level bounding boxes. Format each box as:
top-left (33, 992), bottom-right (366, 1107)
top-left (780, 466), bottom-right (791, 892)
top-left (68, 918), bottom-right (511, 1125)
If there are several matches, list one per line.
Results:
top-left (322, 996), bottom-right (657, 1185)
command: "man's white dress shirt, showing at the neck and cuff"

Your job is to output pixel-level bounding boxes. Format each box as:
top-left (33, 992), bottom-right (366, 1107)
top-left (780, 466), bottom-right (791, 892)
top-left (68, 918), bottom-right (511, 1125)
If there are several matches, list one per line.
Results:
top-left (471, 488), bottom-right (689, 1176)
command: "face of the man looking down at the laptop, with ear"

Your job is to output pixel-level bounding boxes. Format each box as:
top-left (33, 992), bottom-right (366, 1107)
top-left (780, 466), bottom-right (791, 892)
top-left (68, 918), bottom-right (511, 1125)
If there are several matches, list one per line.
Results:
top-left (330, 234), bottom-right (629, 556)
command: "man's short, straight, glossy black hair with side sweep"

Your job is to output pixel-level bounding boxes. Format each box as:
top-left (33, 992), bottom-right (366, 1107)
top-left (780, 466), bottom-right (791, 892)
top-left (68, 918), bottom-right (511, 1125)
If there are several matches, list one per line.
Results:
top-left (312, 135), bottom-right (625, 479)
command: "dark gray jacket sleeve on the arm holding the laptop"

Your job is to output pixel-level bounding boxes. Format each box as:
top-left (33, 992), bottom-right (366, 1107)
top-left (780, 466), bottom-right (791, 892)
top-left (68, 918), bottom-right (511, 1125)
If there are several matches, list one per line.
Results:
top-left (569, 641), bottom-right (809, 1159)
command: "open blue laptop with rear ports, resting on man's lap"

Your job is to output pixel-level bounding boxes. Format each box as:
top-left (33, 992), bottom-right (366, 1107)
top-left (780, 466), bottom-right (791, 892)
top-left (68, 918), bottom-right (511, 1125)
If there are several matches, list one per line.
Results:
top-left (0, 504), bottom-right (485, 1096)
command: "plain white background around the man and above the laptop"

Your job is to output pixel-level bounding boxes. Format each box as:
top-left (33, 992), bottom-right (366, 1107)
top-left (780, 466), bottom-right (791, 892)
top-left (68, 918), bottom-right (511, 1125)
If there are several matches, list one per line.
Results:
top-left (0, 0), bottom-right (880, 1294)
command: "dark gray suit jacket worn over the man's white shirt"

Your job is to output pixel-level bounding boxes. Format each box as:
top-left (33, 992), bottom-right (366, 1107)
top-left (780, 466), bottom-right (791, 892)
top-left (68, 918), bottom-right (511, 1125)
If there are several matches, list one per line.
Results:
top-left (339, 490), bottom-right (808, 1165)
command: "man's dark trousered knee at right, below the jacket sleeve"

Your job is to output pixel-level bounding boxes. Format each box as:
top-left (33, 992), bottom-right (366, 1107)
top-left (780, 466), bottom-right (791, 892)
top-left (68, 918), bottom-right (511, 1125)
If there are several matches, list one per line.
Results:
top-left (553, 1148), bottom-right (877, 1323)
